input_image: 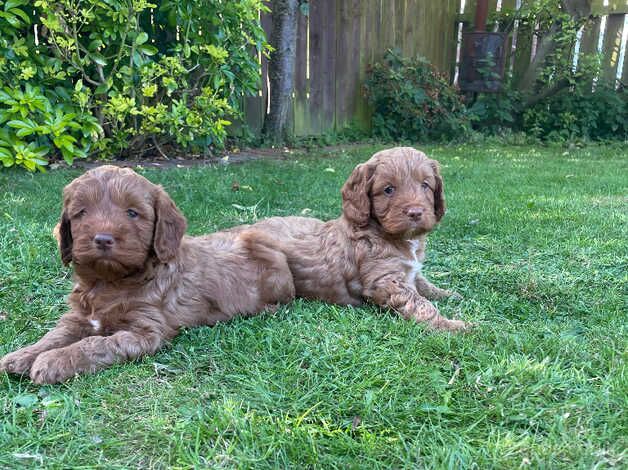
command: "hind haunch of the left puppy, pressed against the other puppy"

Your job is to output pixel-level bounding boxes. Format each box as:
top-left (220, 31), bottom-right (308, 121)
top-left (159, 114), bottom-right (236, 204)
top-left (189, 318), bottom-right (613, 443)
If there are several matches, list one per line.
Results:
top-left (238, 229), bottom-right (295, 304)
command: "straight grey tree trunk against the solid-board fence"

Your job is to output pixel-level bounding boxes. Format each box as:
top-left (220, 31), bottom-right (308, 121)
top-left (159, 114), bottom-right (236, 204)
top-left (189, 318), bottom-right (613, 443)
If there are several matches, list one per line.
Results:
top-left (262, 0), bottom-right (299, 144)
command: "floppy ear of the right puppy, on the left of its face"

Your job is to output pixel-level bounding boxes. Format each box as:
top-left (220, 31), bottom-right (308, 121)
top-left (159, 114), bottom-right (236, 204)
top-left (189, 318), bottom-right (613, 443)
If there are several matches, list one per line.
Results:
top-left (342, 163), bottom-right (375, 227)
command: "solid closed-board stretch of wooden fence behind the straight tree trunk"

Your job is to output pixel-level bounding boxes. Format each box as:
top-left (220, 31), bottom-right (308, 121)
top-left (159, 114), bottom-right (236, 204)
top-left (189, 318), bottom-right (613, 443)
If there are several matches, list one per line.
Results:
top-left (245, 0), bottom-right (460, 135)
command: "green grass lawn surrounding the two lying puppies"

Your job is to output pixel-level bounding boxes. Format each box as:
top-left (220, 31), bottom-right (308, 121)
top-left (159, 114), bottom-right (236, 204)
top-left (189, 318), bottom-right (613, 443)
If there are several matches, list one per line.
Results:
top-left (0, 145), bottom-right (628, 469)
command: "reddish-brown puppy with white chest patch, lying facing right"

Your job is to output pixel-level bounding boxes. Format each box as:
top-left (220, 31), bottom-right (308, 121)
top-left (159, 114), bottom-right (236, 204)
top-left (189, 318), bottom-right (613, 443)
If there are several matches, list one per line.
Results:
top-left (243, 147), bottom-right (469, 331)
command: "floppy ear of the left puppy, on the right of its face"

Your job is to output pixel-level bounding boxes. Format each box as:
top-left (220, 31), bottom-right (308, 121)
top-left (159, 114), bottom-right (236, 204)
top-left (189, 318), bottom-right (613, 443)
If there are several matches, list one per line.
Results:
top-left (153, 187), bottom-right (187, 263)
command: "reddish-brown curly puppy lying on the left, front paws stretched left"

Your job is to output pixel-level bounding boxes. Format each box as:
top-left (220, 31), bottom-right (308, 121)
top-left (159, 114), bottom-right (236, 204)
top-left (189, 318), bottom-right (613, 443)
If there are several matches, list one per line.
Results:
top-left (0, 166), bottom-right (294, 383)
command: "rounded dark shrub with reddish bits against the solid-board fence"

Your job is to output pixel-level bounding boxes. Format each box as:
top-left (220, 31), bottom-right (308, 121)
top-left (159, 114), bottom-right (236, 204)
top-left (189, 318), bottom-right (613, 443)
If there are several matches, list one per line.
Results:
top-left (365, 50), bottom-right (470, 140)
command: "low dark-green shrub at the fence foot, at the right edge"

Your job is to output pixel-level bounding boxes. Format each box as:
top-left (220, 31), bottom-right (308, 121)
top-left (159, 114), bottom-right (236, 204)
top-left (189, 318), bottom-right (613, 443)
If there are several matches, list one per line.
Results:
top-left (523, 84), bottom-right (628, 141)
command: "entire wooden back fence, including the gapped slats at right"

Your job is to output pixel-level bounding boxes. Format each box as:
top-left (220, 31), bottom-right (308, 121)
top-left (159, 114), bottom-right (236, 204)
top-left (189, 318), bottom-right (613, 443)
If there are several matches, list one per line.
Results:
top-left (245, 0), bottom-right (628, 136)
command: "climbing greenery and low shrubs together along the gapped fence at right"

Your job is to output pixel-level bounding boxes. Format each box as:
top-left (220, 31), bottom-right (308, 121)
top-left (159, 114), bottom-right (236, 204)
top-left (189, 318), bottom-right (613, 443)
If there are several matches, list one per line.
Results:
top-left (469, 0), bottom-right (628, 142)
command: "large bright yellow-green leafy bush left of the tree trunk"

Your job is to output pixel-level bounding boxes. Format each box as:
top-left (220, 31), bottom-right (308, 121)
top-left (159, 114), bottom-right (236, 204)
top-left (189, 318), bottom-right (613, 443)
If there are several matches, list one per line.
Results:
top-left (0, 0), bottom-right (268, 170)
